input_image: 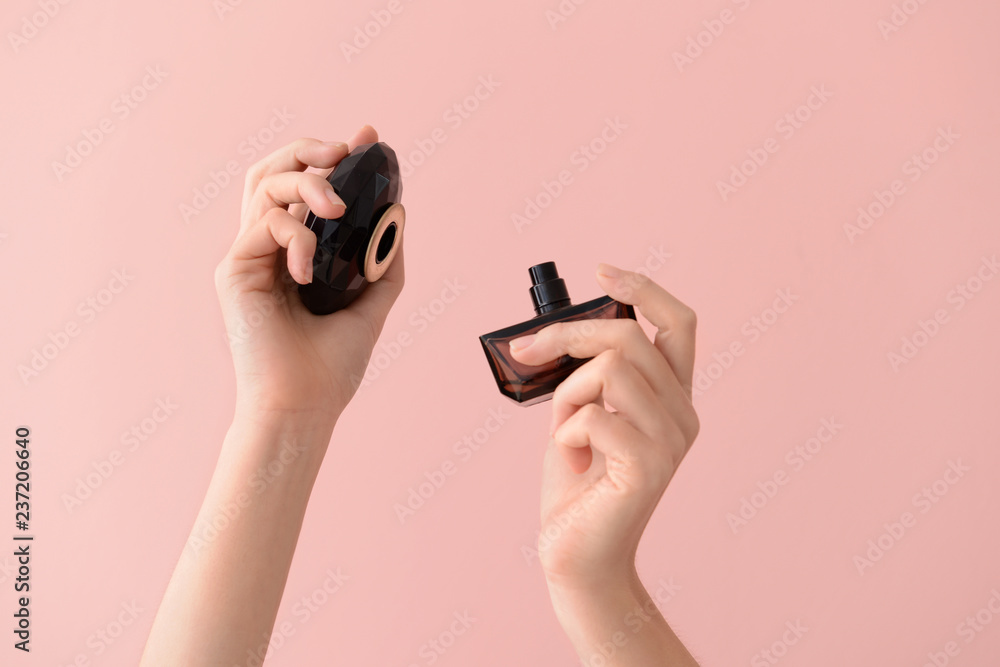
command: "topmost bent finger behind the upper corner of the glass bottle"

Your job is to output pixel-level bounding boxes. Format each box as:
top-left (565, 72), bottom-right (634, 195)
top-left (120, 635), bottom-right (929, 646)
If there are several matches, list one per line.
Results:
top-left (597, 264), bottom-right (698, 396)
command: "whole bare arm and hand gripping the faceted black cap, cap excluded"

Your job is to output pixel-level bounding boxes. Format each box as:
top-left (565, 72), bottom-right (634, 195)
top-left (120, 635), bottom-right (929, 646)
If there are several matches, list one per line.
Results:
top-left (141, 126), bottom-right (404, 667)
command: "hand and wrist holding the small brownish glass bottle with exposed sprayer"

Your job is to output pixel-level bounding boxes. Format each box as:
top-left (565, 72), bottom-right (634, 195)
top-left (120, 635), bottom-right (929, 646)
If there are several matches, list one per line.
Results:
top-left (511, 264), bottom-right (699, 666)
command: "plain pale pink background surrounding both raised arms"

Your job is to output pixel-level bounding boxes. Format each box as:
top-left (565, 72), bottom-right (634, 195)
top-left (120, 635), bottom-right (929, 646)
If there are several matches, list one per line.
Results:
top-left (0, 0), bottom-right (1000, 667)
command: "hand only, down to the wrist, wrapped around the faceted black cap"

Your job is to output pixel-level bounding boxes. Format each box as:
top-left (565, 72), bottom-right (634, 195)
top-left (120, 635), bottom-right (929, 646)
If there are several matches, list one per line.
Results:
top-left (215, 126), bottom-right (403, 424)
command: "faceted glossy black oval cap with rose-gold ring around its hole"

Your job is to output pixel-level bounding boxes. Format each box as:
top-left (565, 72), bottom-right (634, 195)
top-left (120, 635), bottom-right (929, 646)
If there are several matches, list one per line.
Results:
top-left (299, 142), bottom-right (406, 315)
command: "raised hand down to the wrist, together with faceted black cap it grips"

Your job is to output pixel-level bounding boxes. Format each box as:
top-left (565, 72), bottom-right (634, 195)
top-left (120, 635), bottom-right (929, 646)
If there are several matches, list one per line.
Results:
top-left (215, 126), bottom-right (403, 428)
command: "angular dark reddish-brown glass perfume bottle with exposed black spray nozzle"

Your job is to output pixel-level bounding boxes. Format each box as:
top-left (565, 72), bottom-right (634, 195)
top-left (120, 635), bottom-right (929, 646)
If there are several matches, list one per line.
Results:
top-left (479, 262), bottom-right (635, 405)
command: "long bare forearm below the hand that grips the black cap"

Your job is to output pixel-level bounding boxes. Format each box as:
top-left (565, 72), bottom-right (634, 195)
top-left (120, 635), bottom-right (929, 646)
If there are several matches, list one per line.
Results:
top-left (141, 414), bottom-right (333, 667)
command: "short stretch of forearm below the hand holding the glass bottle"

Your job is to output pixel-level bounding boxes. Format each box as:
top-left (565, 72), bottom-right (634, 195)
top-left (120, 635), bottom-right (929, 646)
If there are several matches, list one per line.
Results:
top-left (549, 576), bottom-right (698, 667)
